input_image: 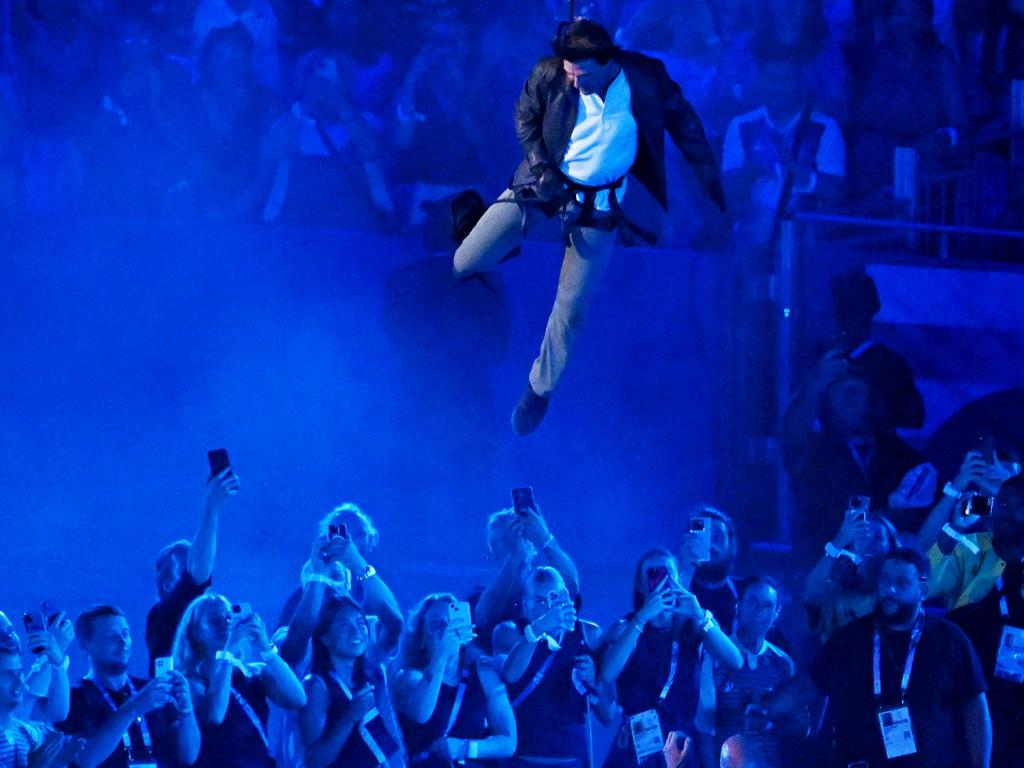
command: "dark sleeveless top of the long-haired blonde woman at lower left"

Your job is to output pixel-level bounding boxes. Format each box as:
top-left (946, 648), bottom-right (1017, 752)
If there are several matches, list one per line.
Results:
top-left (194, 670), bottom-right (276, 768)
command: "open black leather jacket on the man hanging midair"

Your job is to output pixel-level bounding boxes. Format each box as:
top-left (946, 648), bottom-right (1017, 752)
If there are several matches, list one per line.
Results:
top-left (513, 51), bottom-right (725, 210)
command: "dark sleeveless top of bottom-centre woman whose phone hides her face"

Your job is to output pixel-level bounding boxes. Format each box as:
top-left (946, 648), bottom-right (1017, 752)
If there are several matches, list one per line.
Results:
top-left (508, 622), bottom-right (590, 760)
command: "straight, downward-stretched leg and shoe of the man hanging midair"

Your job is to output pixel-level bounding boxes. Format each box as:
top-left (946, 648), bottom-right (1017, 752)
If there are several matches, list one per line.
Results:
top-left (512, 227), bottom-right (615, 435)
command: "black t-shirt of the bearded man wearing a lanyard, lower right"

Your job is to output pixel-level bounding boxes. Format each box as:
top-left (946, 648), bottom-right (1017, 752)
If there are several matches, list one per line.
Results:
top-left (810, 615), bottom-right (987, 768)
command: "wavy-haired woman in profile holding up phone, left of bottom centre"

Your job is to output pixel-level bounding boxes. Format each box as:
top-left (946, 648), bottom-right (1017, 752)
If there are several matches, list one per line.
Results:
top-left (394, 593), bottom-right (516, 768)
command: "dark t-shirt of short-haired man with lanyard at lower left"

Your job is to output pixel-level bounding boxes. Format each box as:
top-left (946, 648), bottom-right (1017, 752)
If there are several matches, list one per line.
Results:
top-left (56, 677), bottom-right (177, 768)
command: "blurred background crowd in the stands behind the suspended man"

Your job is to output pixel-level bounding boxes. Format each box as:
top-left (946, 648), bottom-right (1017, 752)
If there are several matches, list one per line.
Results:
top-left (0, 0), bottom-right (1024, 244)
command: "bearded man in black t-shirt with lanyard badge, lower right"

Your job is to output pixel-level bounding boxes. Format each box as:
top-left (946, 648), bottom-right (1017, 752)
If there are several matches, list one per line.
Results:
top-left (811, 549), bottom-right (991, 768)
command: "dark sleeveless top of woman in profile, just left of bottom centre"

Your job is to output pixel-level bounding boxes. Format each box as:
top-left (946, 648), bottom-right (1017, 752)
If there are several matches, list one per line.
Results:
top-left (398, 665), bottom-right (487, 768)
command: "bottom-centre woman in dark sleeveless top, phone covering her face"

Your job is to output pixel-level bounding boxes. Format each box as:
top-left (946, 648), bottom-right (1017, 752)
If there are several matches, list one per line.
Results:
top-left (493, 566), bottom-right (614, 768)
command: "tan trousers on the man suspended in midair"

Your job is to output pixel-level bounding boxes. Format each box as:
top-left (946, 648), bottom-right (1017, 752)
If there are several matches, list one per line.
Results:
top-left (454, 189), bottom-right (615, 397)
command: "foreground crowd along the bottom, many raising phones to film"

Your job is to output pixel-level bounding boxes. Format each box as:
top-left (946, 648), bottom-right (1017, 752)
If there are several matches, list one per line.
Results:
top-left (0, 387), bottom-right (1024, 768)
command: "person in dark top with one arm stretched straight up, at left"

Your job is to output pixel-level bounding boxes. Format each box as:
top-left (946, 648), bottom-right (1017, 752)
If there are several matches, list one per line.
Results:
top-left (145, 467), bottom-right (239, 676)
